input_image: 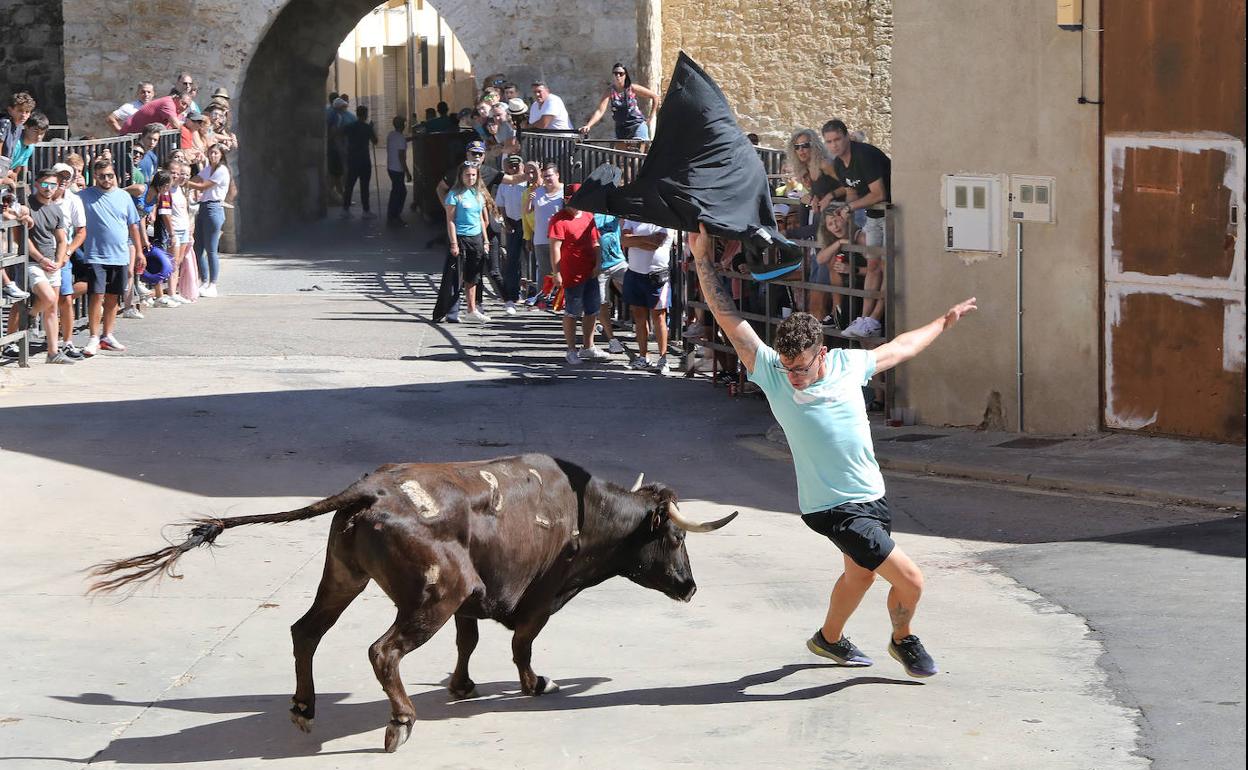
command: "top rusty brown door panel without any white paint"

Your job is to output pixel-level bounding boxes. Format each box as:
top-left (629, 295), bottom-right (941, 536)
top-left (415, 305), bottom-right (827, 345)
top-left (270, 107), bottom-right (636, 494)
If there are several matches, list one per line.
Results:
top-left (1101, 0), bottom-right (1244, 139)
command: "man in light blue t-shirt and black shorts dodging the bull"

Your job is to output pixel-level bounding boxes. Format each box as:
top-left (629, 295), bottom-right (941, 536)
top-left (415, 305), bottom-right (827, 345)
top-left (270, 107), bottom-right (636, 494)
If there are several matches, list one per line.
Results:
top-left (689, 227), bottom-right (975, 676)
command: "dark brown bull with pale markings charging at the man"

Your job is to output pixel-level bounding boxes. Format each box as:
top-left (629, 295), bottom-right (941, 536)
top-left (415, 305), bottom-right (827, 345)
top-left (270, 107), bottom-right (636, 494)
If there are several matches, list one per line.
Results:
top-left (90, 454), bottom-right (736, 751)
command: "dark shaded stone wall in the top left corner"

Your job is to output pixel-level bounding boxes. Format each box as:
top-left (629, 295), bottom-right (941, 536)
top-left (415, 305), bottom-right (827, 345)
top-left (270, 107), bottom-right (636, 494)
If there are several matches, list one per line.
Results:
top-left (0, 0), bottom-right (65, 124)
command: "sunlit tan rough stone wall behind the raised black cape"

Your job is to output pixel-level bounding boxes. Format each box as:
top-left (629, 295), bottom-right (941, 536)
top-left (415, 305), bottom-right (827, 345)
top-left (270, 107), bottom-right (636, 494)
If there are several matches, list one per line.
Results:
top-left (663, 0), bottom-right (892, 150)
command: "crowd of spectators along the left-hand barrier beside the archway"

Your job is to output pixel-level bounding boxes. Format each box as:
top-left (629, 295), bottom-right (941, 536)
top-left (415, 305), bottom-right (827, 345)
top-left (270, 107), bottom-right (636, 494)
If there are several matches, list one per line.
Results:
top-left (0, 72), bottom-right (238, 364)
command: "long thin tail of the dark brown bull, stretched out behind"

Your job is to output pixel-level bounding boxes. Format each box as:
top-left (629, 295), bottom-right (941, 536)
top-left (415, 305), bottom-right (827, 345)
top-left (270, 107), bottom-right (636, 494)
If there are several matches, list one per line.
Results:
top-left (86, 485), bottom-right (376, 594)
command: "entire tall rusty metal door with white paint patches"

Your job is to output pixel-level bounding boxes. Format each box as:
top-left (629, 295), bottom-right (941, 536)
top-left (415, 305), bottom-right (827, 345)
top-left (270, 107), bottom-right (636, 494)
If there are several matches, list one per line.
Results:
top-left (1101, 0), bottom-right (1246, 442)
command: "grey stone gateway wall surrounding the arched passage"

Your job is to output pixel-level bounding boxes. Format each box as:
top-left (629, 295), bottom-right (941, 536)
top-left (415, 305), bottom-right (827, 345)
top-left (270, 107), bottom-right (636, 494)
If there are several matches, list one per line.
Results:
top-left (64, 0), bottom-right (636, 243)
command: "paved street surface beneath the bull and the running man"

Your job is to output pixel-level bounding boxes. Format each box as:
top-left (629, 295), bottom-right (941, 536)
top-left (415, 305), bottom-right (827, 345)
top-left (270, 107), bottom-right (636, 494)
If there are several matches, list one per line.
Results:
top-left (0, 223), bottom-right (1244, 769)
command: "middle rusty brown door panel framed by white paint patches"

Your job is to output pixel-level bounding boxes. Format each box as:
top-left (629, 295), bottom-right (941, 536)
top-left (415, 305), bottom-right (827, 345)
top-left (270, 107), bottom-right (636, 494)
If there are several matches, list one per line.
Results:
top-left (1113, 146), bottom-right (1238, 280)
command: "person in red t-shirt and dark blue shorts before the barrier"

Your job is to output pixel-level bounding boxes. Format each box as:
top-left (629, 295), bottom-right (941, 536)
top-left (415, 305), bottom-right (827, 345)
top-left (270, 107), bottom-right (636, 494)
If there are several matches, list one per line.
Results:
top-left (548, 185), bottom-right (610, 366)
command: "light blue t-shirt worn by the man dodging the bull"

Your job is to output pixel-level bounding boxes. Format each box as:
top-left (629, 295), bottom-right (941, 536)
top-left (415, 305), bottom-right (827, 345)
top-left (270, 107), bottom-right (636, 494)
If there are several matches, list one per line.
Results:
top-left (750, 344), bottom-right (884, 513)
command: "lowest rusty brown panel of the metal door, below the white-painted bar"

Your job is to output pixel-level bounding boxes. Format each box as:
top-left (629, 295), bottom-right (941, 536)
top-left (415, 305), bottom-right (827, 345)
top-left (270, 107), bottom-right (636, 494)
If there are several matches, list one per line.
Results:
top-left (1104, 285), bottom-right (1244, 443)
